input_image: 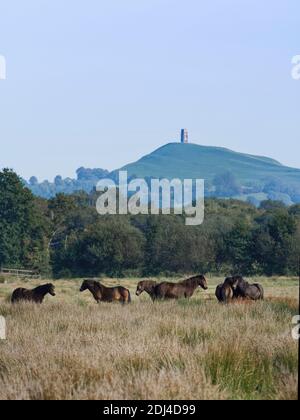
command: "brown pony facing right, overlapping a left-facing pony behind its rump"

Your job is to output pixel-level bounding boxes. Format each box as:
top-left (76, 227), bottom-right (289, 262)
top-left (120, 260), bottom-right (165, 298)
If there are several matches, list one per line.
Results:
top-left (154, 275), bottom-right (208, 299)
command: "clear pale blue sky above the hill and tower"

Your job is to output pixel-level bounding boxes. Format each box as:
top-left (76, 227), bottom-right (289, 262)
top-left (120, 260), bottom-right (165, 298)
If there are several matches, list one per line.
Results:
top-left (0, 0), bottom-right (300, 180)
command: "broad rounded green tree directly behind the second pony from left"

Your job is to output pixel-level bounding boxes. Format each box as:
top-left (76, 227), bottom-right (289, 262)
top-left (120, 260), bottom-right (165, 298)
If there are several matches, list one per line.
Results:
top-left (55, 216), bottom-right (144, 276)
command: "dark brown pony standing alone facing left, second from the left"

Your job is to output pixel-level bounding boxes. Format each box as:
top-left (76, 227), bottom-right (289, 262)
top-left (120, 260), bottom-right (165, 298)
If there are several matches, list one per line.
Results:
top-left (80, 280), bottom-right (131, 304)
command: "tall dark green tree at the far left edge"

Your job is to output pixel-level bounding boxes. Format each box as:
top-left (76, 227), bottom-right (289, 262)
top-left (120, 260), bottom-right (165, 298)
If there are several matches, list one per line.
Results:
top-left (0, 169), bottom-right (49, 270)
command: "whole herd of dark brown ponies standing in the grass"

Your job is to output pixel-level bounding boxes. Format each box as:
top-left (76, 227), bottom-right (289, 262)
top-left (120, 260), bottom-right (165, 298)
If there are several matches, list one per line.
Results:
top-left (11, 275), bottom-right (264, 304)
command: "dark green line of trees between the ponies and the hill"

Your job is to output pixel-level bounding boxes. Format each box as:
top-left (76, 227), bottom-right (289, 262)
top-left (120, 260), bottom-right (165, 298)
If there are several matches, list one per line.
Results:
top-left (0, 169), bottom-right (300, 278)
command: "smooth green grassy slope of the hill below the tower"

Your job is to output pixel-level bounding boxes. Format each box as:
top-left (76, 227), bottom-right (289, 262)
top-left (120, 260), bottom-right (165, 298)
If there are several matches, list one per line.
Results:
top-left (115, 143), bottom-right (300, 185)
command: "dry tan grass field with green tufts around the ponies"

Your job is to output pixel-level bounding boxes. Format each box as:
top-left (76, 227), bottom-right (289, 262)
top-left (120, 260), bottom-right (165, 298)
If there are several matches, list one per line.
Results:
top-left (0, 278), bottom-right (299, 400)
